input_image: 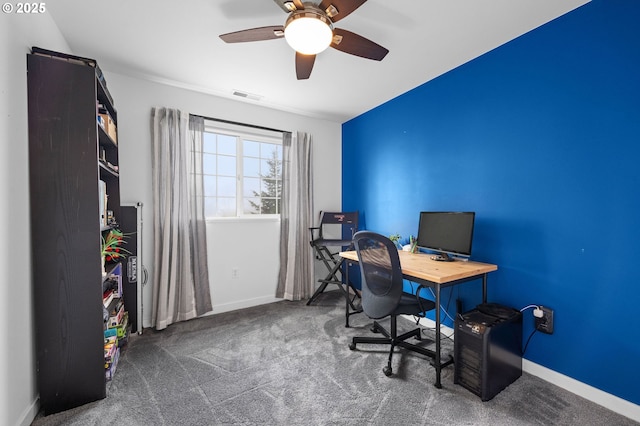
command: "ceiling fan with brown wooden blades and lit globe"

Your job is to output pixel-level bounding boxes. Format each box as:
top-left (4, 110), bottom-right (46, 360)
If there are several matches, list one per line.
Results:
top-left (220, 0), bottom-right (389, 80)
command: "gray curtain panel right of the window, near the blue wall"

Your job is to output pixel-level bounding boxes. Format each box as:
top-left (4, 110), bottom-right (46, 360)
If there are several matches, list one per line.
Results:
top-left (276, 132), bottom-right (315, 300)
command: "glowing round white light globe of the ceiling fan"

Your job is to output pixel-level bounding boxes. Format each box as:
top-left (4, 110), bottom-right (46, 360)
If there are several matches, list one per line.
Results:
top-left (284, 12), bottom-right (333, 55)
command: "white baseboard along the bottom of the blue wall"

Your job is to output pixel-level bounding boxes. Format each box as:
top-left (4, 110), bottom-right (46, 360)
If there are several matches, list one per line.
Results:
top-left (406, 316), bottom-right (640, 422)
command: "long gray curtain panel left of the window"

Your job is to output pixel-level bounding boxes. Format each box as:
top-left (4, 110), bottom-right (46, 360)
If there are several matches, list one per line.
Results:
top-left (152, 108), bottom-right (211, 330)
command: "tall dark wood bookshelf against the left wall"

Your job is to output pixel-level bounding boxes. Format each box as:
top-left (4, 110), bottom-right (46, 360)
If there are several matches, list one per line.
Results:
top-left (27, 48), bottom-right (120, 414)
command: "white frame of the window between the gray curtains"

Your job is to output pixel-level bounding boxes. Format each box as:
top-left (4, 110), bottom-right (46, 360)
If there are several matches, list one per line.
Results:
top-left (202, 119), bottom-right (284, 221)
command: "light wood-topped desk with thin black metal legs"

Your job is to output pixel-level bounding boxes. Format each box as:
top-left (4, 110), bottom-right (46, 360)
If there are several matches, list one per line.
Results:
top-left (340, 250), bottom-right (498, 388)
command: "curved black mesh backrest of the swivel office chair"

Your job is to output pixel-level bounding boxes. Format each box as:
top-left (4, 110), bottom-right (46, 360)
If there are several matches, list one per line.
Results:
top-left (353, 231), bottom-right (402, 319)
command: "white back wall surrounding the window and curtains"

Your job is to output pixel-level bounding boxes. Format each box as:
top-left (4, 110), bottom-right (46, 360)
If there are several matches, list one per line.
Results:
top-left (104, 72), bottom-right (342, 327)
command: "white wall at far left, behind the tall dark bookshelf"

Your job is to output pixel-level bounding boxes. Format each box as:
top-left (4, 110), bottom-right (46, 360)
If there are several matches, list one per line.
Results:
top-left (0, 13), bottom-right (69, 426)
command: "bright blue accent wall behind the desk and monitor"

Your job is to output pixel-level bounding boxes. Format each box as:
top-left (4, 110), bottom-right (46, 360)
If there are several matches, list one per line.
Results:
top-left (342, 0), bottom-right (640, 404)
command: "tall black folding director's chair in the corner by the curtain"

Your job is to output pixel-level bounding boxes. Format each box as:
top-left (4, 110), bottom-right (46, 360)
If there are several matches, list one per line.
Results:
top-left (307, 211), bottom-right (358, 310)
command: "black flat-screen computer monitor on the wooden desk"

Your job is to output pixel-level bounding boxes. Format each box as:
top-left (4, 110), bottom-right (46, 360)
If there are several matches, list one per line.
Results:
top-left (417, 212), bottom-right (476, 262)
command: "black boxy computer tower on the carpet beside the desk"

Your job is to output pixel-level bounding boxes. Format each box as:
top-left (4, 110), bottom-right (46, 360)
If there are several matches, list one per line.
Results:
top-left (453, 304), bottom-right (522, 401)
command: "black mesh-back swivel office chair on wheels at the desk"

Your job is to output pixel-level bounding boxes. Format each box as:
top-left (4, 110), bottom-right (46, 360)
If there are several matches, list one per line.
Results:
top-left (349, 231), bottom-right (435, 376)
